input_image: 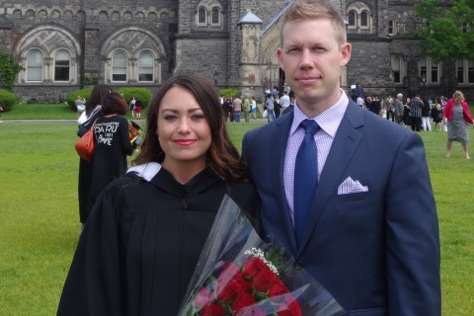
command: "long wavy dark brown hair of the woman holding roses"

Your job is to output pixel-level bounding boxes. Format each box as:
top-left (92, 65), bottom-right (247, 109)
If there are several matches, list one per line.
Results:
top-left (134, 75), bottom-right (246, 181)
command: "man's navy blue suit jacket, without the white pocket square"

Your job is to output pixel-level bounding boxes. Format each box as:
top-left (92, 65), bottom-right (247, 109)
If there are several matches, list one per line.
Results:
top-left (242, 101), bottom-right (441, 316)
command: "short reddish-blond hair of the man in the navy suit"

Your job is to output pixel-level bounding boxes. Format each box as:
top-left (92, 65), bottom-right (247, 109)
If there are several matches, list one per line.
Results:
top-left (280, 0), bottom-right (347, 45)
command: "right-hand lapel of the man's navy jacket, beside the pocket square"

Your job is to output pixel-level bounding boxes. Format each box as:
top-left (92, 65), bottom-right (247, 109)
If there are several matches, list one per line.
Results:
top-left (298, 102), bottom-right (363, 256)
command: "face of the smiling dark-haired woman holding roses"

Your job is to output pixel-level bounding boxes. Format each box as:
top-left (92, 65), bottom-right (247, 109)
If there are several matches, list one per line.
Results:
top-left (156, 87), bottom-right (212, 168)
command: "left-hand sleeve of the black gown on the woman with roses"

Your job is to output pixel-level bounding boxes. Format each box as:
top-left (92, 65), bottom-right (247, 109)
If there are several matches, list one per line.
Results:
top-left (57, 191), bottom-right (126, 316)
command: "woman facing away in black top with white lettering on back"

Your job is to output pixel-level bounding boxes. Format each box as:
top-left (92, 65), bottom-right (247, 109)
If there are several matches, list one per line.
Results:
top-left (89, 92), bottom-right (133, 214)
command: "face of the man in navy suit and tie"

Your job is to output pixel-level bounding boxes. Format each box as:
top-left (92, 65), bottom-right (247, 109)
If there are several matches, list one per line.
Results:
top-left (277, 18), bottom-right (351, 112)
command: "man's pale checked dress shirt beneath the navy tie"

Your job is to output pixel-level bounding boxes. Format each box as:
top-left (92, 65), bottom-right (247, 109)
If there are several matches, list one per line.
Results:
top-left (283, 90), bottom-right (349, 220)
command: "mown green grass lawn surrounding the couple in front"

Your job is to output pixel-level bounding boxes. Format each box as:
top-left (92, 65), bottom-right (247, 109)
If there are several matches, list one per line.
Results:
top-left (0, 120), bottom-right (474, 316)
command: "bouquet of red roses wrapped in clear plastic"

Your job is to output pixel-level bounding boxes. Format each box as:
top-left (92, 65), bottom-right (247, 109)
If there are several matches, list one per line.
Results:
top-left (179, 197), bottom-right (343, 316)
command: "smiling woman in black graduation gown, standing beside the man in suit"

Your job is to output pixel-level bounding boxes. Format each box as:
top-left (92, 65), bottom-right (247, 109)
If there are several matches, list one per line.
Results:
top-left (57, 75), bottom-right (258, 316)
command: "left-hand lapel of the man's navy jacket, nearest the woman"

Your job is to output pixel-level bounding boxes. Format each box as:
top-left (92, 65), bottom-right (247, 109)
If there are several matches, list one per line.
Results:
top-left (273, 112), bottom-right (297, 253)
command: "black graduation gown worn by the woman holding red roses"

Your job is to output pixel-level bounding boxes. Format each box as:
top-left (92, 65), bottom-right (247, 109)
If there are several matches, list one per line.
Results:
top-left (57, 168), bottom-right (258, 316)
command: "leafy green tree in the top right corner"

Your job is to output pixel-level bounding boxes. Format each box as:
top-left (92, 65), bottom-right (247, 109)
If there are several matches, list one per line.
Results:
top-left (416, 0), bottom-right (474, 62)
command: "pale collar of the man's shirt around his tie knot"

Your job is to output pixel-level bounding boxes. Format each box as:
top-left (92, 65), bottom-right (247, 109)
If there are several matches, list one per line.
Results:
top-left (290, 89), bottom-right (349, 138)
